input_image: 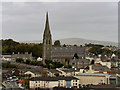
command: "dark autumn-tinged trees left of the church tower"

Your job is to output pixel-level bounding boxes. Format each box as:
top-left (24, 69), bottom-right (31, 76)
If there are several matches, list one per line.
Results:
top-left (2, 39), bottom-right (42, 57)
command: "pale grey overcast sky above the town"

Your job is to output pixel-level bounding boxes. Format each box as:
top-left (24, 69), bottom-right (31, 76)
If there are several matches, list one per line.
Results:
top-left (2, 2), bottom-right (118, 42)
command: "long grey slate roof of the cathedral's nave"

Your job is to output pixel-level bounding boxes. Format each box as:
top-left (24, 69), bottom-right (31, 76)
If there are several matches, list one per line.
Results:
top-left (52, 46), bottom-right (85, 54)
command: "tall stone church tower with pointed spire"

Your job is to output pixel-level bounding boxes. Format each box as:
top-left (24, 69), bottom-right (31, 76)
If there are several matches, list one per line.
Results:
top-left (42, 12), bottom-right (52, 65)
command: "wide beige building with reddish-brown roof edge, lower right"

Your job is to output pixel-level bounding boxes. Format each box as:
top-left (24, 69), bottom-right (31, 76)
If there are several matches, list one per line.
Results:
top-left (75, 73), bottom-right (110, 85)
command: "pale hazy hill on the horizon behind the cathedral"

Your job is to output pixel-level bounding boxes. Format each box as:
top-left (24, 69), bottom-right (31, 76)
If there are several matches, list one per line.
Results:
top-left (22, 38), bottom-right (118, 46)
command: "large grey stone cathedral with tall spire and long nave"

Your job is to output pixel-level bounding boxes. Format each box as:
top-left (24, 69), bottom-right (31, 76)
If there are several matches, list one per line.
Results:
top-left (43, 12), bottom-right (85, 64)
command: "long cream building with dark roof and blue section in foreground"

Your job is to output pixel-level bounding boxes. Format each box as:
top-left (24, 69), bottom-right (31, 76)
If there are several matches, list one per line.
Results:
top-left (29, 77), bottom-right (79, 89)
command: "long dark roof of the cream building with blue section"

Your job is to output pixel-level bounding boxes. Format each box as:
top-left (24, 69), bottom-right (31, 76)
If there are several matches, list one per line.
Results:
top-left (30, 77), bottom-right (78, 81)
